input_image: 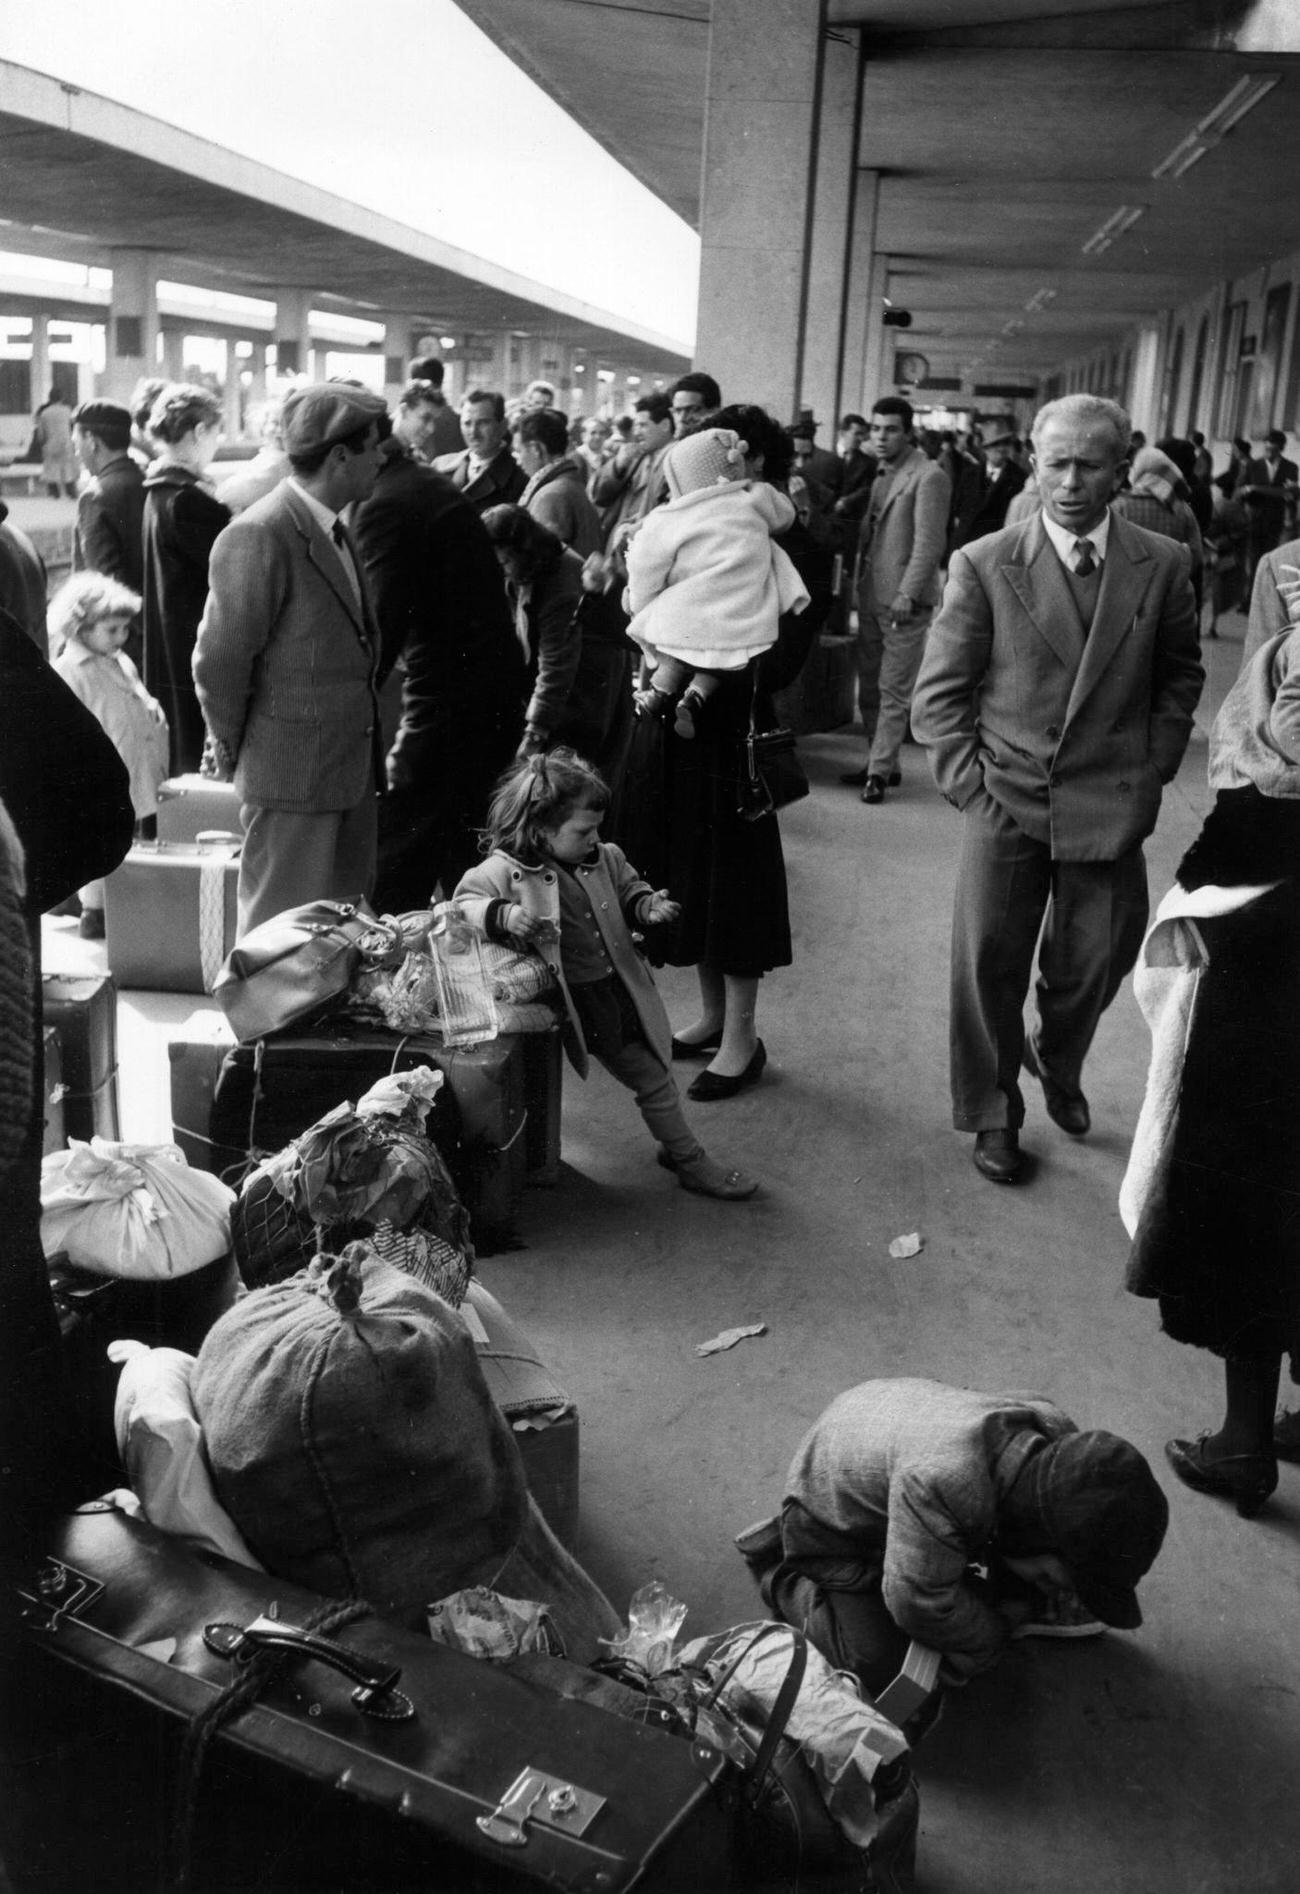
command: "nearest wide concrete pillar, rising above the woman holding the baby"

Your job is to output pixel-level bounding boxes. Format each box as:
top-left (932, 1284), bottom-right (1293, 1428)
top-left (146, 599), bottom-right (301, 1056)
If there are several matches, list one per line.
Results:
top-left (695, 0), bottom-right (826, 420)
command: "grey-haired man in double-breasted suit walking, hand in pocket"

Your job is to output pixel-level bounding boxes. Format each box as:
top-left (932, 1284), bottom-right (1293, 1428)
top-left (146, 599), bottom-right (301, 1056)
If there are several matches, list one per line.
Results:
top-left (912, 394), bottom-right (1205, 1184)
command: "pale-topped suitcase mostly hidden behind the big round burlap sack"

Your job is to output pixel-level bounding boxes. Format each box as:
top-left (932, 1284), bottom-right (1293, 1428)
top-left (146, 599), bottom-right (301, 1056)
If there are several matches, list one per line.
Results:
top-left (460, 1280), bottom-right (580, 1551)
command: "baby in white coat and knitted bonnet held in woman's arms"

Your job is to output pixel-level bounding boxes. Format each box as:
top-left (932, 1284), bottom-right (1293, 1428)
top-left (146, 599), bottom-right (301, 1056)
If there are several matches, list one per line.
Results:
top-left (627, 428), bottom-right (807, 737)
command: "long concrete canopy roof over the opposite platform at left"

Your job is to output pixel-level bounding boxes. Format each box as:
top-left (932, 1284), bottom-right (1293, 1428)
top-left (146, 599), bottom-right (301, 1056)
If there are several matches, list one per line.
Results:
top-left (0, 61), bottom-right (688, 373)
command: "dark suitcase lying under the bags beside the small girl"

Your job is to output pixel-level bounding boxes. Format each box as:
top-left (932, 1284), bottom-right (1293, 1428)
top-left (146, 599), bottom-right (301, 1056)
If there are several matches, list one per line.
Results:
top-left (171, 1021), bottom-right (529, 1252)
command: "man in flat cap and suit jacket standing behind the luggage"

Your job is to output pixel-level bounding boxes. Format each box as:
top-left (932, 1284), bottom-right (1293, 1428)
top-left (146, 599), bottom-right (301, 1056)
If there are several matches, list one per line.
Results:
top-left (193, 383), bottom-right (388, 938)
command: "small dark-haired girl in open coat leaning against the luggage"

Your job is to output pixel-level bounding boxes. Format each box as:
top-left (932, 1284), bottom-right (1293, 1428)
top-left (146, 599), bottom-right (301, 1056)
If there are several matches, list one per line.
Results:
top-left (455, 748), bottom-right (758, 1199)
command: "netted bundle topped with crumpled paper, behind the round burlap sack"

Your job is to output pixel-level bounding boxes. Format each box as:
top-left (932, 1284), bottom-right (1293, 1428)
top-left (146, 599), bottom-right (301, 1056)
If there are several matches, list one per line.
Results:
top-left (231, 1066), bottom-right (474, 1309)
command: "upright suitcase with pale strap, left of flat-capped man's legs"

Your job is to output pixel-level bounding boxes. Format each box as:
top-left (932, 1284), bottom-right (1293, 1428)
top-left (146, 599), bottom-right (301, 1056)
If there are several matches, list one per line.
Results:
top-left (104, 835), bottom-right (239, 992)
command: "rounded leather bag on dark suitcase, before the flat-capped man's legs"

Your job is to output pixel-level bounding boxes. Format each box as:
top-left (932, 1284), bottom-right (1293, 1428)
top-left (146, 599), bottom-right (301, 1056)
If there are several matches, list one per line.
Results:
top-left (212, 902), bottom-right (404, 1044)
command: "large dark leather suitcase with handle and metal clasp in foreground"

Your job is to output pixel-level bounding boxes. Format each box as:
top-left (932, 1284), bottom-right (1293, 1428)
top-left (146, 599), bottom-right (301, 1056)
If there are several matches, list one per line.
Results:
top-left (0, 1502), bottom-right (731, 1894)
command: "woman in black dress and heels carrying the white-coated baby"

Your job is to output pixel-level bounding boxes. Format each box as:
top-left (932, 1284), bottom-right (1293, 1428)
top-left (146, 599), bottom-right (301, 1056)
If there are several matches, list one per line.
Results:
top-left (616, 405), bottom-right (830, 1102)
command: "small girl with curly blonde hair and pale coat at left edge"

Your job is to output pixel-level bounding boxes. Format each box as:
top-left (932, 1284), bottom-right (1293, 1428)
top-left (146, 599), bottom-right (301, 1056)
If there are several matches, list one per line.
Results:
top-left (49, 572), bottom-right (169, 939)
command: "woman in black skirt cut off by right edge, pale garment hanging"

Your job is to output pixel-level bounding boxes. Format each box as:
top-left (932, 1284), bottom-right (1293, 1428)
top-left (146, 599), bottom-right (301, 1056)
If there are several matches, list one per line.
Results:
top-left (1120, 598), bottom-right (1300, 1519)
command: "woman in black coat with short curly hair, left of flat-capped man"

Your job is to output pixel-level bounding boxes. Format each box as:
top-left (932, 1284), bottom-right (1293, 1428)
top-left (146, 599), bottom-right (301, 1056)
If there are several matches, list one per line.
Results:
top-left (144, 383), bottom-right (231, 777)
